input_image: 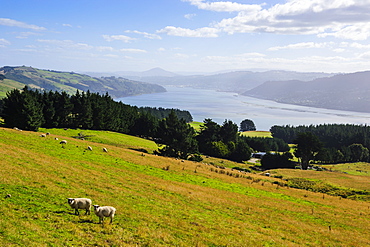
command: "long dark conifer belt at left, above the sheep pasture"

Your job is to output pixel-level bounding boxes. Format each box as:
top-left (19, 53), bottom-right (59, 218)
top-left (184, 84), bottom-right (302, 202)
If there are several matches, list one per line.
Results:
top-left (0, 86), bottom-right (192, 135)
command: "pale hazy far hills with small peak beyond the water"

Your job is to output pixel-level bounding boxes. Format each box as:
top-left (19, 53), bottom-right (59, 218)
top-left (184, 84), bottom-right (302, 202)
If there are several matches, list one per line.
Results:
top-left (119, 69), bottom-right (333, 93)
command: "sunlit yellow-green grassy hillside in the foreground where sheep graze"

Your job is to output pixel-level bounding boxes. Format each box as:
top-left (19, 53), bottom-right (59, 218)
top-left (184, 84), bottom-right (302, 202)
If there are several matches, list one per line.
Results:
top-left (0, 128), bottom-right (370, 246)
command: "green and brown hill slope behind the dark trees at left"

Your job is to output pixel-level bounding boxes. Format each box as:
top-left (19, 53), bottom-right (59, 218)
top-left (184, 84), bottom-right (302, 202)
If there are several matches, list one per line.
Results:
top-left (0, 66), bottom-right (166, 98)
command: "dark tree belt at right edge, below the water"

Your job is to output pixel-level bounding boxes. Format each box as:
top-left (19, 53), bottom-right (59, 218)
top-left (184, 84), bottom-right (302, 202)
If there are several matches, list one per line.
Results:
top-left (270, 124), bottom-right (370, 166)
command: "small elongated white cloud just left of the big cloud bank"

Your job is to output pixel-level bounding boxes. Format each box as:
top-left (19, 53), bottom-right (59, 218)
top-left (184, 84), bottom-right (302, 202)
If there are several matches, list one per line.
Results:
top-left (157, 26), bottom-right (219, 38)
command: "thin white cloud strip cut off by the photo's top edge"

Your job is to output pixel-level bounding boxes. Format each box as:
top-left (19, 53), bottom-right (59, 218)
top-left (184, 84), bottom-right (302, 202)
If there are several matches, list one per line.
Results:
top-left (183, 0), bottom-right (261, 12)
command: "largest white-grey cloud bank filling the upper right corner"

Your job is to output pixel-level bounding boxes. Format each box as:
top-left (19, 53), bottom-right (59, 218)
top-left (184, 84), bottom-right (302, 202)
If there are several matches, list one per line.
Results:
top-left (214, 0), bottom-right (370, 40)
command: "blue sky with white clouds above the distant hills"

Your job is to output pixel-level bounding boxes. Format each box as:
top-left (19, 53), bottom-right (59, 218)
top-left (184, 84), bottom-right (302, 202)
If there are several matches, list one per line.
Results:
top-left (0, 0), bottom-right (370, 73)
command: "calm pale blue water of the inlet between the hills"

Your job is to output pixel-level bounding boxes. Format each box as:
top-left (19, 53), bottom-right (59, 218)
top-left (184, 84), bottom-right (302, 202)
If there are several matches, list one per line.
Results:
top-left (117, 87), bottom-right (370, 130)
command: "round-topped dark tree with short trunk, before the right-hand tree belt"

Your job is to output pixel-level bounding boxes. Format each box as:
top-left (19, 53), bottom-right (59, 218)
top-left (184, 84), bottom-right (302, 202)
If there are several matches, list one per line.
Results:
top-left (293, 132), bottom-right (322, 170)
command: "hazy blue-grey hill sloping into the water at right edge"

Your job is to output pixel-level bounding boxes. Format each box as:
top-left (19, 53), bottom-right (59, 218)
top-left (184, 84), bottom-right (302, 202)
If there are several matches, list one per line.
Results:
top-left (243, 71), bottom-right (370, 112)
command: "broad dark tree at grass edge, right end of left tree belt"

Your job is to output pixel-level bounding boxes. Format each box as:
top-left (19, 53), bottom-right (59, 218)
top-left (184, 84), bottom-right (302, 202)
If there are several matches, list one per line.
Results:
top-left (155, 111), bottom-right (198, 159)
